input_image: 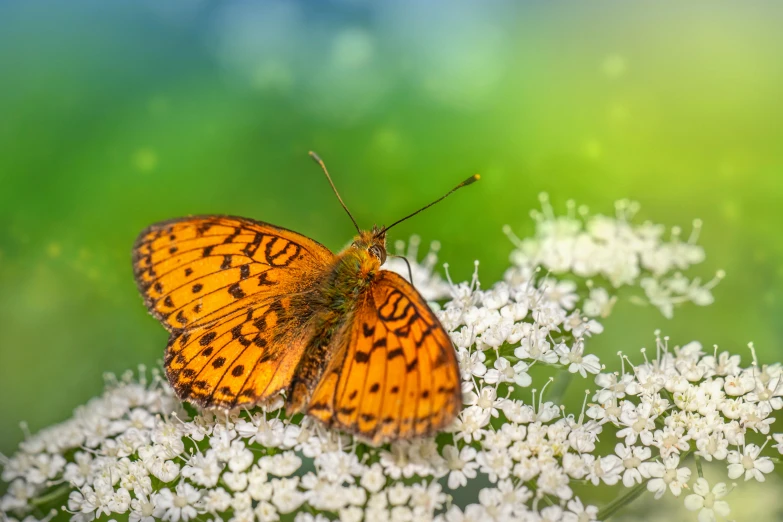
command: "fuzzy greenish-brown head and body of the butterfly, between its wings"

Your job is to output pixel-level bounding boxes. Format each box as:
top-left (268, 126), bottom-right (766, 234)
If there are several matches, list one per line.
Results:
top-left (288, 227), bottom-right (386, 412)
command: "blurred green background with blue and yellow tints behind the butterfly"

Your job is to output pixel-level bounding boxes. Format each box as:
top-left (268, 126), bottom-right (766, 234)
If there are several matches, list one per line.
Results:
top-left (0, 0), bottom-right (783, 472)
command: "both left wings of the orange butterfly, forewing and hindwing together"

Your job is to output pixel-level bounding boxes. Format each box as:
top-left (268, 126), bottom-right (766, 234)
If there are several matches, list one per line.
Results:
top-left (133, 216), bottom-right (334, 407)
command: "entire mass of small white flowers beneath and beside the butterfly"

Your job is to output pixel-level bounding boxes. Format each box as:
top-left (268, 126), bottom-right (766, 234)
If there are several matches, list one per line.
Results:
top-left (0, 196), bottom-right (783, 522)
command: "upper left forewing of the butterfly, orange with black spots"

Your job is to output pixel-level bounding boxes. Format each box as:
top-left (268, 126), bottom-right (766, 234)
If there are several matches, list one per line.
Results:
top-left (133, 216), bottom-right (334, 330)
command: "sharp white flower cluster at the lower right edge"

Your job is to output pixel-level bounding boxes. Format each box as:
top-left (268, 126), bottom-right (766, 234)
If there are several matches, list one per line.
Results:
top-left (587, 336), bottom-right (783, 522)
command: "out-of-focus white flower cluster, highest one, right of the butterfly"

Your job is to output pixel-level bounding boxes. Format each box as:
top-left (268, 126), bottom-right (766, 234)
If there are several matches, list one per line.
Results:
top-left (504, 194), bottom-right (724, 318)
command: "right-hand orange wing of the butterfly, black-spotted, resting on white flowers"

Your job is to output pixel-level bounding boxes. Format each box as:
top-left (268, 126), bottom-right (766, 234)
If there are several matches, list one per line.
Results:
top-left (308, 270), bottom-right (462, 443)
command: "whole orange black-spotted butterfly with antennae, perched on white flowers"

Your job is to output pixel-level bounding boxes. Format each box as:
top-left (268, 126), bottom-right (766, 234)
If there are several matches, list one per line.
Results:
top-left (133, 153), bottom-right (478, 444)
